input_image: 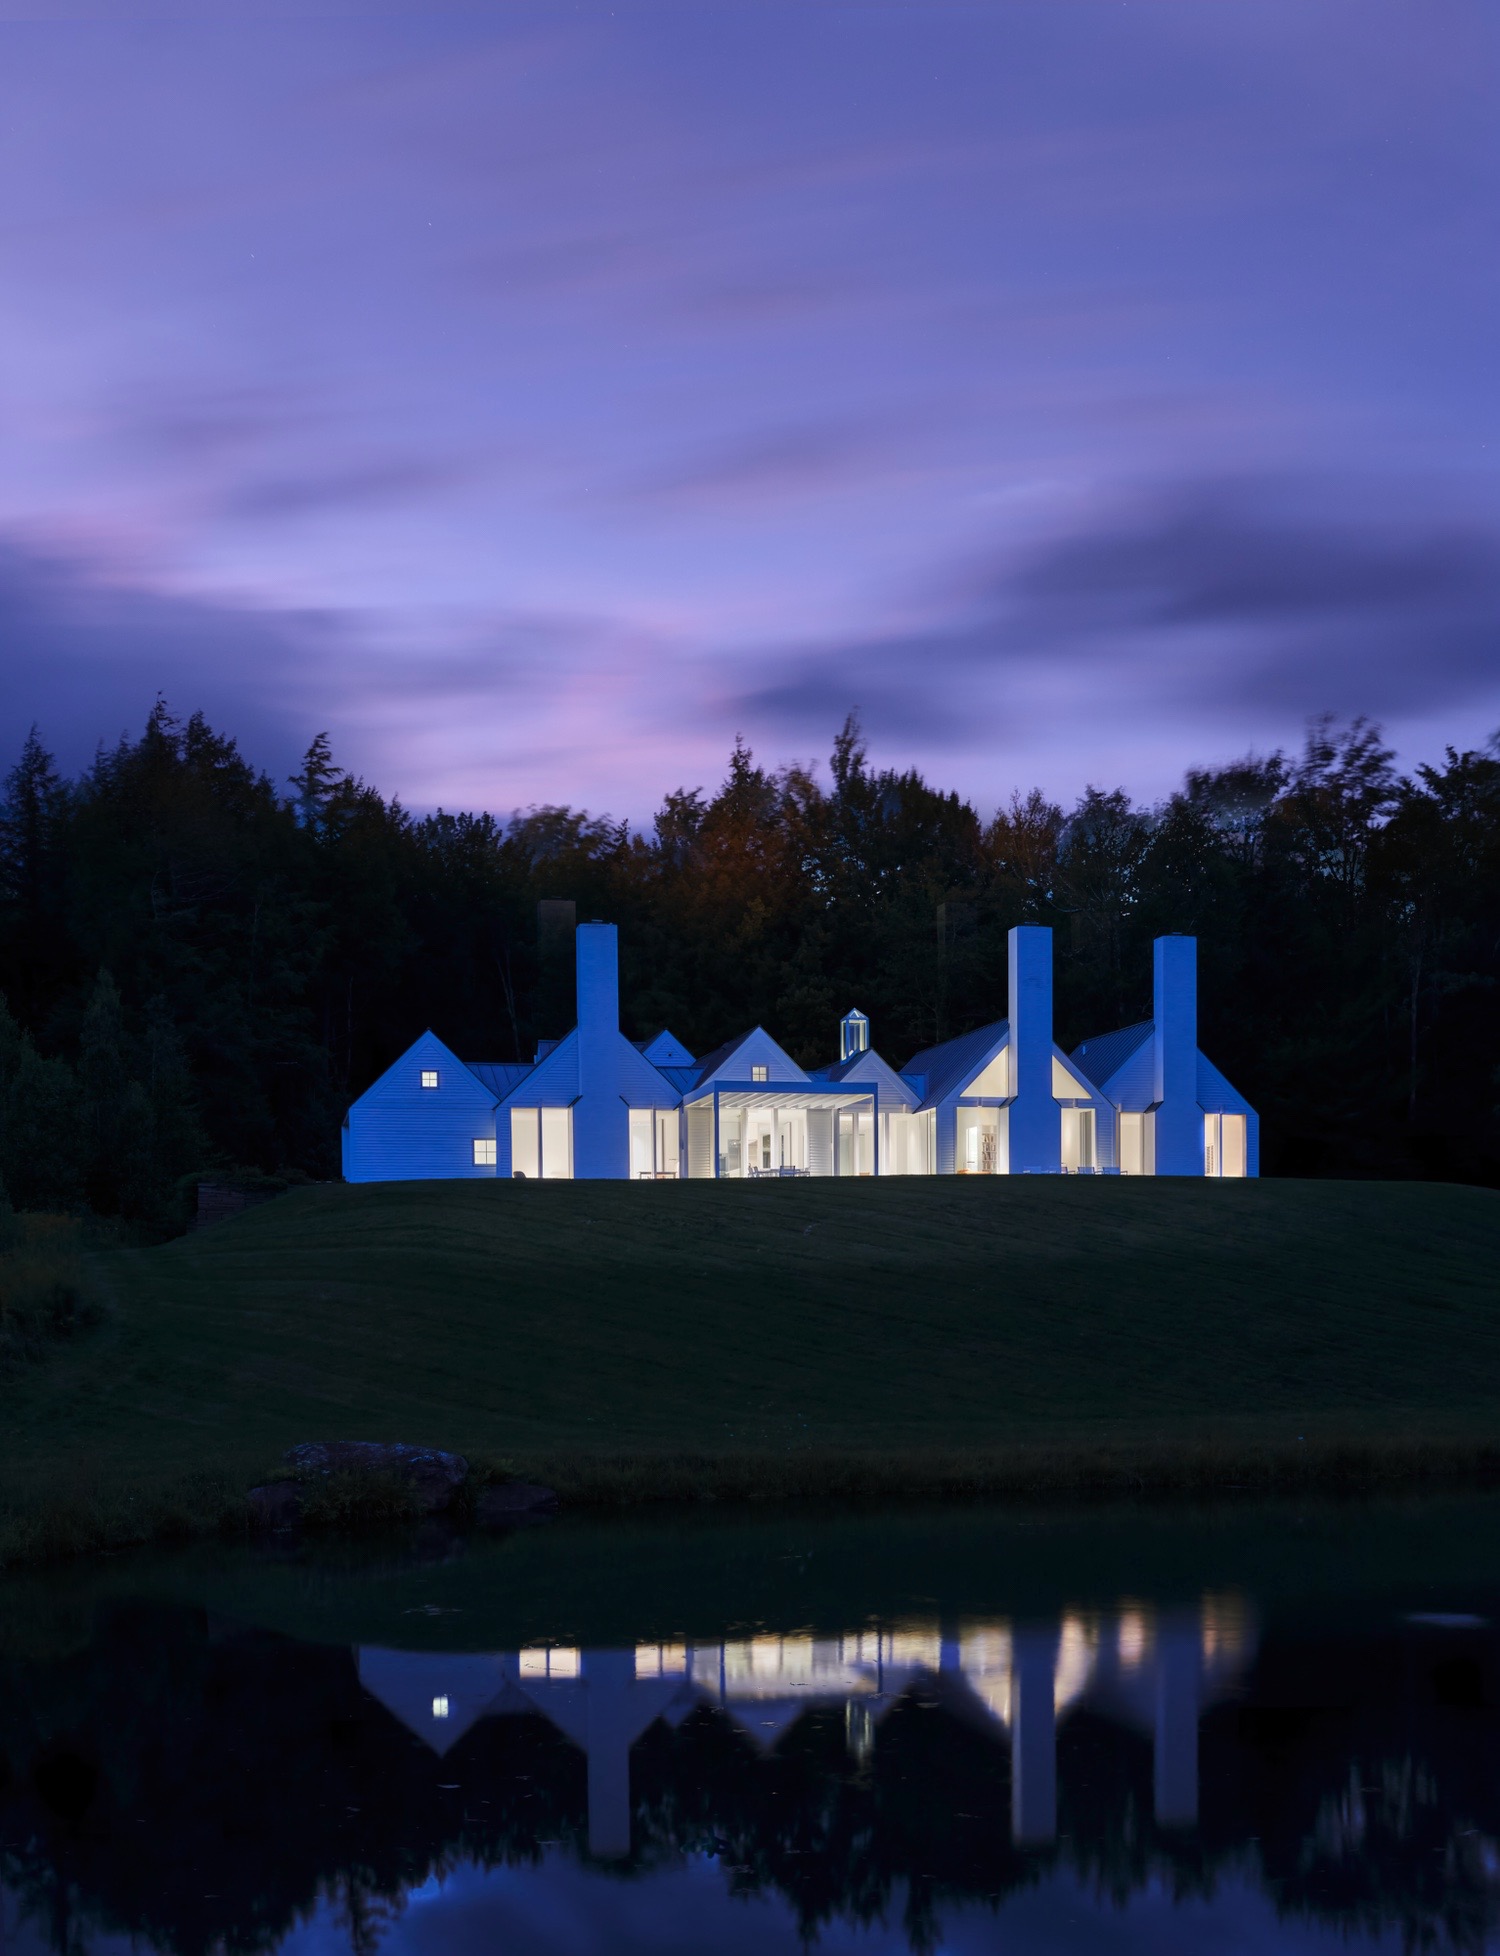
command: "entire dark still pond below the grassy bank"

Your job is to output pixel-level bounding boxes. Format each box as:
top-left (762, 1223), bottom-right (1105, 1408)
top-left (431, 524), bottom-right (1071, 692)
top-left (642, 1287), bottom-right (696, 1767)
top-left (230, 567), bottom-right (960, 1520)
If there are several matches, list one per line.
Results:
top-left (0, 1496), bottom-right (1500, 1956)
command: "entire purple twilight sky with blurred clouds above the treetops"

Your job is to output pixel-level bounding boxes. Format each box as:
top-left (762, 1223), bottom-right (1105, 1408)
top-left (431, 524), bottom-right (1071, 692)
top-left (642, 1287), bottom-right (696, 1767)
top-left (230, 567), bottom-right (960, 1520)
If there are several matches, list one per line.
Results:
top-left (0, 0), bottom-right (1500, 822)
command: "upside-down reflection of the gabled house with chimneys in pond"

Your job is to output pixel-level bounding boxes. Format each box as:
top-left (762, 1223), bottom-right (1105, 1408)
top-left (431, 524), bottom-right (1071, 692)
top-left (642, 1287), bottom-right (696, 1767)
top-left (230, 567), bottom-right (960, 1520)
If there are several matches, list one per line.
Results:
top-left (358, 1598), bottom-right (1254, 1856)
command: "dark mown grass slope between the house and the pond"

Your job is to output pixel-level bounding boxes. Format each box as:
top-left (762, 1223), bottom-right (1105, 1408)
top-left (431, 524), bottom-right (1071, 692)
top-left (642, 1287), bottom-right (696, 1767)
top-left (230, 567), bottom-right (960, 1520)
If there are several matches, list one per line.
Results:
top-left (0, 1178), bottom-right (1500, 1559)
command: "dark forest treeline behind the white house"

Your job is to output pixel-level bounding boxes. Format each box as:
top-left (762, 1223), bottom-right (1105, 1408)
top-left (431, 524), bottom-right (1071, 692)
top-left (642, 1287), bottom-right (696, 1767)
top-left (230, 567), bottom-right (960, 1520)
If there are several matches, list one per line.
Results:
top-left (0, 704), bottom-right (1500, 1226)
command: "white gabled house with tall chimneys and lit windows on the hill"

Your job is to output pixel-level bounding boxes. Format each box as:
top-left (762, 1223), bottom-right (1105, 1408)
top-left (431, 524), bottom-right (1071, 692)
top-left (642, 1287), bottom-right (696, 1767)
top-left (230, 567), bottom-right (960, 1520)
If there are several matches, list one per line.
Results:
top-left (344, 923), bottom-right (1259, 1181)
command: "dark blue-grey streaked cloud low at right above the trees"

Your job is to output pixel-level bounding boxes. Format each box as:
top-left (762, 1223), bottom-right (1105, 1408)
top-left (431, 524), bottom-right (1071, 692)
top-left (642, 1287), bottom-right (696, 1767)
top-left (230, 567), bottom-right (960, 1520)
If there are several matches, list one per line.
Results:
top-left (731, 479), bottom-right (1500, 747)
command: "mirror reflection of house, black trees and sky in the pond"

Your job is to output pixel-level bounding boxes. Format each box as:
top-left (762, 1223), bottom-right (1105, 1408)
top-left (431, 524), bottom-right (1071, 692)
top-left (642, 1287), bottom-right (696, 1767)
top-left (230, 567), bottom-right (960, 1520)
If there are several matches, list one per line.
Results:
top-left (0, 1549), bottom-right (1500, 1956)
